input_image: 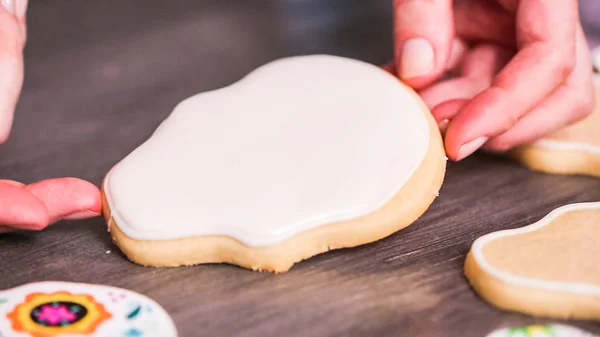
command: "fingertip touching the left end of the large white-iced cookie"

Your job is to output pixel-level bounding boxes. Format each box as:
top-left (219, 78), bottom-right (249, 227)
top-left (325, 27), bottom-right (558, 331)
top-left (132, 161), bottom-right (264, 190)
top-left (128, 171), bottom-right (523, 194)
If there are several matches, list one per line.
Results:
top-left (25, 178), bottom-right (102, 223)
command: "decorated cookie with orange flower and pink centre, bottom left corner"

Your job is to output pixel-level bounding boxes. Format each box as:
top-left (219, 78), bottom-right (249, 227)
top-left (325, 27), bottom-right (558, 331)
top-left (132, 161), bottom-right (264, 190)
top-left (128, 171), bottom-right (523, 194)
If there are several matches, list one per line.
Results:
top-left (0, 282), bottom-right (177, 337)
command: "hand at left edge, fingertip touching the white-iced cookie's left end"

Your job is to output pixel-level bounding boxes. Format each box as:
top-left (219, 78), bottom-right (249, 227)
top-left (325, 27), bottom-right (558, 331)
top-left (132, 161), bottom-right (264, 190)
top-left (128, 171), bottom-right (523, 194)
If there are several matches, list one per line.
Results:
top-left (0, 0), bottom-right (102, 233)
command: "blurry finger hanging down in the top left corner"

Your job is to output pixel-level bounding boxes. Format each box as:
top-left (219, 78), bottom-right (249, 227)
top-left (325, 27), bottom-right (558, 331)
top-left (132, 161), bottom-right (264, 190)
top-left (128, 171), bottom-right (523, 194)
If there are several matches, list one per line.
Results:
top-left (0, 0), bottom-right (26, 143)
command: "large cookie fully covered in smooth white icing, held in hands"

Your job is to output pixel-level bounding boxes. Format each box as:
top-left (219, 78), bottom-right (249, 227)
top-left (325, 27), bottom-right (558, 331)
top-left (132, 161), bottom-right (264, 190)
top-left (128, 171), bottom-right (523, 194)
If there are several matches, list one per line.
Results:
top-left (103, 55), bottom-right (446, 272)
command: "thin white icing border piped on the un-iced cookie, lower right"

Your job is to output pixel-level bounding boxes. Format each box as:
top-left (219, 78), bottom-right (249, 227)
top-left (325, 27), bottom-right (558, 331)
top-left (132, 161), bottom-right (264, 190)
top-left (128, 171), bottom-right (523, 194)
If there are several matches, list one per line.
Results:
top-left (472, 202), bottom-right (600, 296)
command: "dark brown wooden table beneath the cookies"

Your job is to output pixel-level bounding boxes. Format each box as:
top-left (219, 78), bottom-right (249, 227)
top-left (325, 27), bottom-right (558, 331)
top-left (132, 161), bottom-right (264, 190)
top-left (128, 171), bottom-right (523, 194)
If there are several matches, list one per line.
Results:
top-left (0, 0), bottom-right (600, 337)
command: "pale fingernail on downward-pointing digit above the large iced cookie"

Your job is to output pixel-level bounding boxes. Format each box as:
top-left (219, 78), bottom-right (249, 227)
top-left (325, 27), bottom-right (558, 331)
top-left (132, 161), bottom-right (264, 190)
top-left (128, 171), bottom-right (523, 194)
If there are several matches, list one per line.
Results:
top-left (400, 38), bottom-right (435, 79)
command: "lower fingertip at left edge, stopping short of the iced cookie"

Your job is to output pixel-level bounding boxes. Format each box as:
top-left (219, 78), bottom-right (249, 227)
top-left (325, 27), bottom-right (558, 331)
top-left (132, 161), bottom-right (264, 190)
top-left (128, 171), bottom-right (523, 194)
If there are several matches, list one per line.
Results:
top-left (0, 183), bottom-right (48, 230)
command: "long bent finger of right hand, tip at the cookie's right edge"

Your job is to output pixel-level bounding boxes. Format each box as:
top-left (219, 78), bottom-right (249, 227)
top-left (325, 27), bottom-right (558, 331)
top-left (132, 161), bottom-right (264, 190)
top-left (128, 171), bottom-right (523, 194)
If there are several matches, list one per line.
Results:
top-left (445, 0), bottom-right (578, 160)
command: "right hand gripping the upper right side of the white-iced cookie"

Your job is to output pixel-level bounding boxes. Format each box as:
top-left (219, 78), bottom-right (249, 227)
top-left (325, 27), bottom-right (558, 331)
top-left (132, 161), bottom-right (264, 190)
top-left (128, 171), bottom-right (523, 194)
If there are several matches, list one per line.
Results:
top-left (384, 0), bottom-right (595, 161)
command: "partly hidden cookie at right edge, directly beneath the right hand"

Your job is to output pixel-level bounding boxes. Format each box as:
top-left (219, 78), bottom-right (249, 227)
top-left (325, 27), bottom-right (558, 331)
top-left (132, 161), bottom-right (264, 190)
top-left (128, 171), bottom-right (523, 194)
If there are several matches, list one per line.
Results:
top-left (512, 74), bottom-right (600, 177)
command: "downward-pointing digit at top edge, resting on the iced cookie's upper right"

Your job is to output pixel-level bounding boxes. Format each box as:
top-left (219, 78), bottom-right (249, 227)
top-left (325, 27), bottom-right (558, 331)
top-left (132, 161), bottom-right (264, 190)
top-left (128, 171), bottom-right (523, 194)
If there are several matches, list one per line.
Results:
top-left (394, 0), bottom-right (454, 89)
